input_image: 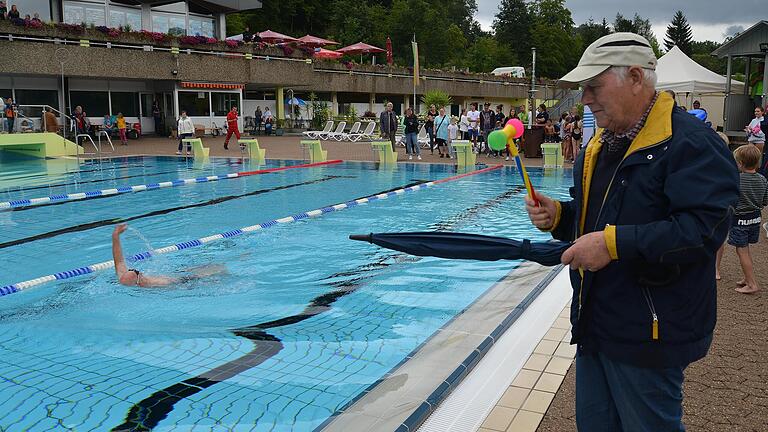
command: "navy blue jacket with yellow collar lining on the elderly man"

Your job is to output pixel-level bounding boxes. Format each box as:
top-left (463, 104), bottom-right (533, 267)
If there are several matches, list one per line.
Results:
top-left (552, 93), bottom-right (739, 367)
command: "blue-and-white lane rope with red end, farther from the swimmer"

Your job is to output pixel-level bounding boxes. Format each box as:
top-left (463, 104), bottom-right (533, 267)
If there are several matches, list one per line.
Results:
top-left (0, 159), bottom-right (343, 210)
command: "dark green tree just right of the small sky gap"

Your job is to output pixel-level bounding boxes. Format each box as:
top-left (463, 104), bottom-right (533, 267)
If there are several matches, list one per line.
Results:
top-left (493, 0), bottom-right (533, 64)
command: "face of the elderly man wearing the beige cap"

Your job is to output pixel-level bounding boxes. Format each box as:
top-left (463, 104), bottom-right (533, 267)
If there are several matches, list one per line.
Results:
top-left (581, 70), bottom-right (635, 130)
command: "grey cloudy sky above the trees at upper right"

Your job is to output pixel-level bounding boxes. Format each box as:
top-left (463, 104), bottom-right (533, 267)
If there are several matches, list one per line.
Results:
top-left (476, 0), bottom-right (766, 42)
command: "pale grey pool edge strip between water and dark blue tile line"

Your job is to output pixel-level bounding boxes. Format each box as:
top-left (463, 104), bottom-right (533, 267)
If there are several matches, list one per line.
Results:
top-left (322, 263), bottom-right (550, 432)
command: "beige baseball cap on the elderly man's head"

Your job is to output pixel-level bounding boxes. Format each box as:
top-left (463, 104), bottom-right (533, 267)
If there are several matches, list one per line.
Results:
top-left (559, 32), bottom-right (656, 86)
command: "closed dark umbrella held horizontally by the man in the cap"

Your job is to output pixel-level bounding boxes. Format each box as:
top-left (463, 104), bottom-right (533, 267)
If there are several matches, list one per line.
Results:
top-left (349, 232), bottom-right (571, 266)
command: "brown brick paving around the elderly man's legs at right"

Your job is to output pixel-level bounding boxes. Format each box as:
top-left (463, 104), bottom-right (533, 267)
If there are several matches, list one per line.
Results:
top-left (538, 211), bottom-right (768, 432)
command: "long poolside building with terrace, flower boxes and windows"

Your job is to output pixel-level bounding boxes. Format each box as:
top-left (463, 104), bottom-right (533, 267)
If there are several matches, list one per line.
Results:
top-left (0, 0), bottom-right (554, 137)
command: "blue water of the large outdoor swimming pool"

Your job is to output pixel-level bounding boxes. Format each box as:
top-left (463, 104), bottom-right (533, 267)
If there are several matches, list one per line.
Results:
top-left (0, 157), bottom-right (568, 431)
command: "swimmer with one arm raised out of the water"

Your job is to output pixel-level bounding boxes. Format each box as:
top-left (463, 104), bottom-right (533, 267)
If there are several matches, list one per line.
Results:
top-left (112, 224), bottom-right (226, 288)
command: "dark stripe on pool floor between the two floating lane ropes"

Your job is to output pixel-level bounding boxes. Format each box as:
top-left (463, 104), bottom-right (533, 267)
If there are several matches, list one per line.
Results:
top-left (0, 175), bottom-right (357, 249)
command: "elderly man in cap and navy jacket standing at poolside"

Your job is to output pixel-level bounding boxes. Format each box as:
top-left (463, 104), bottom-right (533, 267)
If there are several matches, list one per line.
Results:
top-left (526, 33), bottom-right (739, 432)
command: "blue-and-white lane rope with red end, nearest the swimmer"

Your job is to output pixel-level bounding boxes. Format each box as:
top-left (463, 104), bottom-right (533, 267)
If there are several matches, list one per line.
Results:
top-left (0, 165), bottom-right (503, 297)
